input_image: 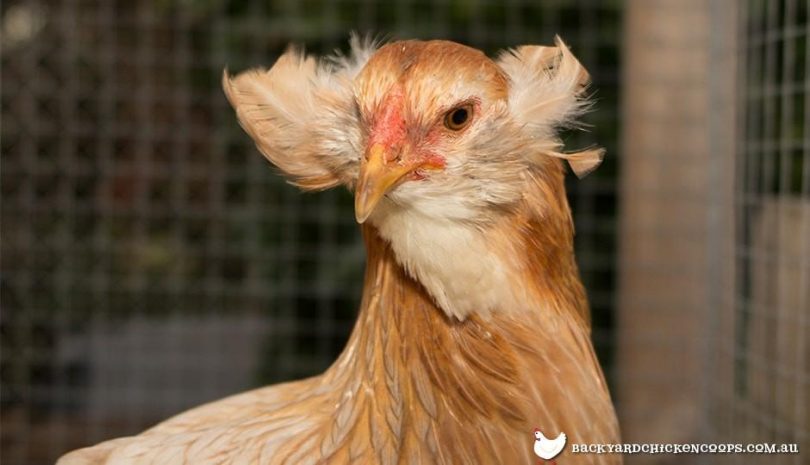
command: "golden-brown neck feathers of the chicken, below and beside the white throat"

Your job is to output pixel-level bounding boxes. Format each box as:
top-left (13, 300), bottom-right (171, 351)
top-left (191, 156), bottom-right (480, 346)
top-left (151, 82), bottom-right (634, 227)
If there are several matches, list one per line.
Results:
top-left (274, 163), bottom-right (620, 464)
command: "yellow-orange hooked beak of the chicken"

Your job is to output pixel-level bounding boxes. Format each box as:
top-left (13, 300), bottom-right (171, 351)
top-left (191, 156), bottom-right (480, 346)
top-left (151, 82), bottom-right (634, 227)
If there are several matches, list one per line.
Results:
top-left (354, 144), bottom-right (415, 224)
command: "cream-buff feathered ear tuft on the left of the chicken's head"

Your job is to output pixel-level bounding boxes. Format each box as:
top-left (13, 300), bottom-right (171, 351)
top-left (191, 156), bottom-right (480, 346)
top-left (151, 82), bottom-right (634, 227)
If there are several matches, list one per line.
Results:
top-left (222, 37), bottom-right (374, 190)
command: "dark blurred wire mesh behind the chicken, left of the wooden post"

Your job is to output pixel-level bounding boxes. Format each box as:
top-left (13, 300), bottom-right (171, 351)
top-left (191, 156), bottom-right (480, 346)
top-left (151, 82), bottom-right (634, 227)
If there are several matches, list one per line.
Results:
top-left (0, 0), bottom-right (622, 465)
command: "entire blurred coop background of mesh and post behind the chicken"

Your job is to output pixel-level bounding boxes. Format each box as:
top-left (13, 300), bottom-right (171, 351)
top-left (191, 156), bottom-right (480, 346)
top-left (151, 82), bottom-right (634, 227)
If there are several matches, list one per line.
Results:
top-left (0, 0), bottom-right (810, 465)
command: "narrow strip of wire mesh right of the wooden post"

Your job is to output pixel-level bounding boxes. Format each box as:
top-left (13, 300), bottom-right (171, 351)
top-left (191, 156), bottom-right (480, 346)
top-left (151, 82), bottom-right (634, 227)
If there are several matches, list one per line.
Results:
top-left (713, 0), bottom-right (810, 464)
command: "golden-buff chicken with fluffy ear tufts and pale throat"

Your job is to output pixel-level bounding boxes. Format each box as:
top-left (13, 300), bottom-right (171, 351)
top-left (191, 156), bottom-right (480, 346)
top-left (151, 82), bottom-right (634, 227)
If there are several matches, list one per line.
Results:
top-left (59, 38), bottom-right (621, 465)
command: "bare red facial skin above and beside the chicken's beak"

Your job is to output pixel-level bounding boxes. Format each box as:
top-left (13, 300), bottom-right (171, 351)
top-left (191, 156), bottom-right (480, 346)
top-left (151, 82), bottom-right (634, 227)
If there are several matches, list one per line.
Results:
top-left (368, 87), bottom-right (447, 181)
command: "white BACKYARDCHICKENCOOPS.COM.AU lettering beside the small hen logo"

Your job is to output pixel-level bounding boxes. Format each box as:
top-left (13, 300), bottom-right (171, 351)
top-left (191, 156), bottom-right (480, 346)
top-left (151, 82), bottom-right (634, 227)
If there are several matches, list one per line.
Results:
top-left (571, 442), bottom-right (799, 454)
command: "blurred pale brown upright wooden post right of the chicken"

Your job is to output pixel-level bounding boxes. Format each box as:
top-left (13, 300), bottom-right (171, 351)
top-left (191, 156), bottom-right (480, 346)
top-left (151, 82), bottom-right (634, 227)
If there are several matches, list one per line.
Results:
top-left (617, 0), bottom-right (737, 463)
